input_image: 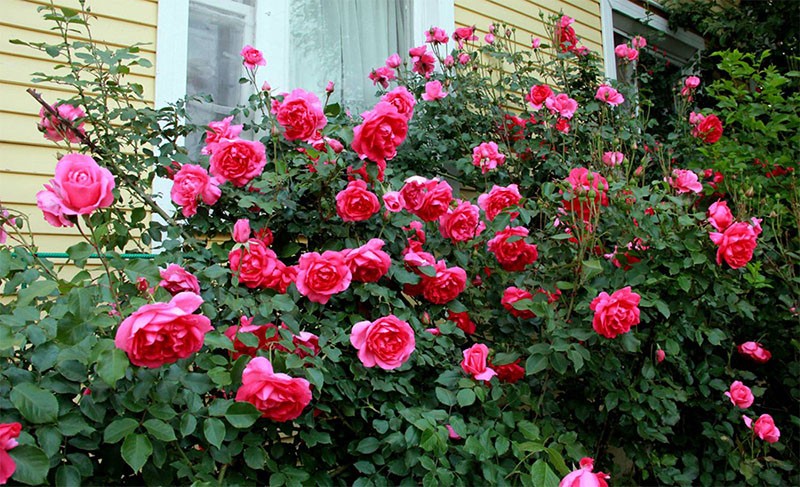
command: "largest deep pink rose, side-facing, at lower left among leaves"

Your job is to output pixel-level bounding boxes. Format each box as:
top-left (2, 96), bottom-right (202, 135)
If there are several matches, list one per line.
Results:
top-left (114, 292), bottom-right (213, 368)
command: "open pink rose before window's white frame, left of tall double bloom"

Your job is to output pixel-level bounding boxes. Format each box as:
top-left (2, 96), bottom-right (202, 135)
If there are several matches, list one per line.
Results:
top-left (272, 88), bottom-right (328, 140)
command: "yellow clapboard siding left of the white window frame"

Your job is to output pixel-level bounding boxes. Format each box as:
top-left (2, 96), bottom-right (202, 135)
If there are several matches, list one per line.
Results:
top-left (0, 0), bottom-right (158, 252)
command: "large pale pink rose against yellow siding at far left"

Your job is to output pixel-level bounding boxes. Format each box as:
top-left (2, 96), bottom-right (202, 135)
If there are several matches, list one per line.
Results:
top-left (36, 154), bottom-right (115, 226)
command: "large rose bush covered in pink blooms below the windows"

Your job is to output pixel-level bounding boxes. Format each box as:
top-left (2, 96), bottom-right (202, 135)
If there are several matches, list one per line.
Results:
top-left (0, 9), bottom-right (800, 485)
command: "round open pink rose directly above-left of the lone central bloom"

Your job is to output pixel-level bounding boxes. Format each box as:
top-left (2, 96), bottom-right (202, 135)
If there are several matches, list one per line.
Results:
top-left (295, 250), bottom-right (353, 304)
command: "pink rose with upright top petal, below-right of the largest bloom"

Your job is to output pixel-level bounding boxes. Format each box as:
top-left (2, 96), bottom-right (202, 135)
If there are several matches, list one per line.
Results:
top-left (236, 357), bottom-right (311, 422)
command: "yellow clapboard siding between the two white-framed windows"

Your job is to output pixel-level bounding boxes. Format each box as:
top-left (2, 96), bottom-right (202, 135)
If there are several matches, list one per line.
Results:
top-left (455, 0), bottom-right (603, 57)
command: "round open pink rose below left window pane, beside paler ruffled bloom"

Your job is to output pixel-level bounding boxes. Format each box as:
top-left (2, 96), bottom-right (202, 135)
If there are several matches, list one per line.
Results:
top-left (209, 139), bottom-right (267, 188)
